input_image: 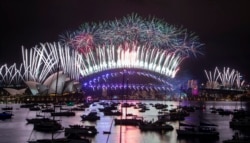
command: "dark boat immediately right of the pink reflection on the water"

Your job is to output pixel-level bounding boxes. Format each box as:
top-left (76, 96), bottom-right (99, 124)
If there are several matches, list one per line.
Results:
top-left (139, 121), bottom-right (174, 131)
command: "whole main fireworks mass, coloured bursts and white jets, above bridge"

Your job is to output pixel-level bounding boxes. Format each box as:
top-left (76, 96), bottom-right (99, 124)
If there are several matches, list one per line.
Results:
top-left (0, 14), bottom-right (203, 92)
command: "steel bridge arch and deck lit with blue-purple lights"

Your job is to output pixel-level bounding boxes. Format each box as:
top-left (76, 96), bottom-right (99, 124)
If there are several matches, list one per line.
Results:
top-left (81, 68), bottom-right (174, 91)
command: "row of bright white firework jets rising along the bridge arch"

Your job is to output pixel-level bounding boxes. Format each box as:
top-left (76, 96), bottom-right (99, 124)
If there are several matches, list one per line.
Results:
top-left (79, 43), bottom-right (184, 78)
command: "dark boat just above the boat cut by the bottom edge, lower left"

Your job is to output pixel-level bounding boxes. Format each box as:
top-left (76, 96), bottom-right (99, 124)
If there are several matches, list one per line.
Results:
top-left (64, 125), bottom-right (98, 137)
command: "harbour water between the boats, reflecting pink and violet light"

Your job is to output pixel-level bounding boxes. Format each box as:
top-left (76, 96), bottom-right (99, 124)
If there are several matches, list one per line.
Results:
top-left (0, 100), bottom-right (249, 143)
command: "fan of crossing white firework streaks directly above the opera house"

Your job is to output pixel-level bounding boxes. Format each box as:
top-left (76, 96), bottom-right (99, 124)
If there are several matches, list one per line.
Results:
top-left (22, 43), bottom-right (79, 83)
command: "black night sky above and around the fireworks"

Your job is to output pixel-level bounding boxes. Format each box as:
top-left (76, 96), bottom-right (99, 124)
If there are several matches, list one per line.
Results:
top-left (0, 0), bottom-right (250, 81)
